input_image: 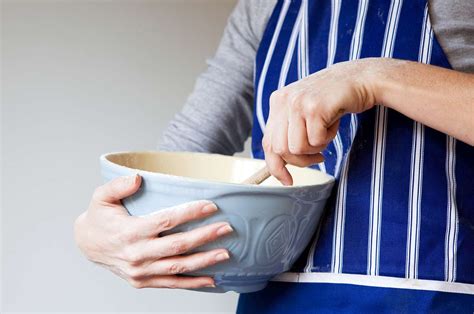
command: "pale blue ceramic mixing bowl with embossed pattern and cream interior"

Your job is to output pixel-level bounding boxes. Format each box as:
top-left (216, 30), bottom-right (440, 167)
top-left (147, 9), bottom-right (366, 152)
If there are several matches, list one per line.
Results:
top-left (100, 152), bottom-right (334, 293)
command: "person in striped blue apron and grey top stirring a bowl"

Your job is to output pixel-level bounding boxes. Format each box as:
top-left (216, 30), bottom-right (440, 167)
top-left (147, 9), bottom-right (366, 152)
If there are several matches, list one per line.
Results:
top-left (75, 0), bottom-right (474, 313)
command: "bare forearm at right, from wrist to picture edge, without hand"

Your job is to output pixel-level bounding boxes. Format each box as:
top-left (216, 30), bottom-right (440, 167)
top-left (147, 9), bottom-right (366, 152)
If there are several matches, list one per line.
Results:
top-left (373, 59), bottom-right (474, 145)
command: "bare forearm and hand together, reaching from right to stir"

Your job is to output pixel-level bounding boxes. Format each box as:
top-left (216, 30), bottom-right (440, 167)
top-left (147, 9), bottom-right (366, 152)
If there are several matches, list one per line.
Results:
top-left (263, 58), bottom-right (474, 184)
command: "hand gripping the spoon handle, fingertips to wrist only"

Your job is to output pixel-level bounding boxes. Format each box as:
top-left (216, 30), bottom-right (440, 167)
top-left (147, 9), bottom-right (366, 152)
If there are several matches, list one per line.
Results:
top-left (262, 59), bottom-right (381, 185)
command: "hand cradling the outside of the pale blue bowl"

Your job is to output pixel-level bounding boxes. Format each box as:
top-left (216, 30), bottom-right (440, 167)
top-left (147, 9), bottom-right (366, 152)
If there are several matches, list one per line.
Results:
top-left (74, 175), bottom-right (233, 288)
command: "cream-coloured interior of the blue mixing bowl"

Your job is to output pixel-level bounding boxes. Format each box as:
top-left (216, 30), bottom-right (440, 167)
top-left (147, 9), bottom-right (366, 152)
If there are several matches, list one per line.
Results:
top-left (105, 152), bottom-right (332, 186)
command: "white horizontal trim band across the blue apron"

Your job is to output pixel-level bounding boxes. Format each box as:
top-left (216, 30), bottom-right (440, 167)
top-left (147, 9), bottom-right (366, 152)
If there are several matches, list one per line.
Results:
top-left (271, 272), bottom-right (474, 295)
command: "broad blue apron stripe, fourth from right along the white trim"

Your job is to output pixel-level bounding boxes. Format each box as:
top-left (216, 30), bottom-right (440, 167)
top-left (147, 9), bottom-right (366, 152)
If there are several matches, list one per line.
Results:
top-left (342, 0), bottom-right (390, 274)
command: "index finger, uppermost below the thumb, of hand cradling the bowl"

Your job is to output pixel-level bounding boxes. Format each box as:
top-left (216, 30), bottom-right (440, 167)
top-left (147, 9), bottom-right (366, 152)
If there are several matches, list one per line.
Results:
top-left (136, 201), bottom-right (217, 237)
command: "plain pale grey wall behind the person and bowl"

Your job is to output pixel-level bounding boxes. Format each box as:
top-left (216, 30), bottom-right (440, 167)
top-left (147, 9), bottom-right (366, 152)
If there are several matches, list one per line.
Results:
top-left (1, 0), bottom-right (244, 312)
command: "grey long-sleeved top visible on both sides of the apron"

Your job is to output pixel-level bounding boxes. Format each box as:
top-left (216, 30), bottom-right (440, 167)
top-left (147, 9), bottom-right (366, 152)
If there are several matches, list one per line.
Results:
top-left (159, 0), bottom-right (474, 155)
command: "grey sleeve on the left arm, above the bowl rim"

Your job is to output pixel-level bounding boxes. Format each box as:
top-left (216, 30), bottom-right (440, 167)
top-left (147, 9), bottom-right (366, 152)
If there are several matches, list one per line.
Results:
top-left (159, 0), bottom-right (274, 155)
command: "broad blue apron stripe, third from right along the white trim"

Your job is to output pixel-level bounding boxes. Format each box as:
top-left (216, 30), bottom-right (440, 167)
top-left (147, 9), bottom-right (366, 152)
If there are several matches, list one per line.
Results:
top-left (379, 1), bottom-right (425, 277)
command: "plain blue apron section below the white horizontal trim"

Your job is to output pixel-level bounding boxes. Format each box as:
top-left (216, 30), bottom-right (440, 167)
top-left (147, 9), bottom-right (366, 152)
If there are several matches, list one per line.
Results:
top-left (237, 282), bottom-right (474, 314)
